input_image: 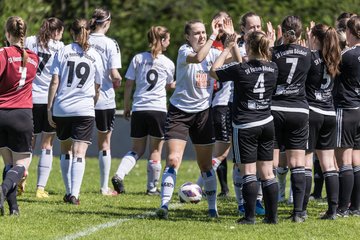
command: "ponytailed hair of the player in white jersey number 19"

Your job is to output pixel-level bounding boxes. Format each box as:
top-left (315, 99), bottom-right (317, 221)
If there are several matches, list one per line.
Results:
top-left (70, 18), bottom-right (90, 52)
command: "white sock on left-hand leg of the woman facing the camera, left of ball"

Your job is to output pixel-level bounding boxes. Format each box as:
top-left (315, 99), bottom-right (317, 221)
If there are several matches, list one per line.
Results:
top-left (160, 167), bottom-right (177, 208)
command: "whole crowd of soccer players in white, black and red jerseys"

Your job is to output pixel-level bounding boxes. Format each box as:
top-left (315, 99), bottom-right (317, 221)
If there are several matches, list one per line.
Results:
top-left (0, 8), bottom-right (360, 224)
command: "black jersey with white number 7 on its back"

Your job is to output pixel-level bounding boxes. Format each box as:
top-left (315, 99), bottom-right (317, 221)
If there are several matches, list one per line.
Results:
top-left (271, 44), bottom-right (311, 111)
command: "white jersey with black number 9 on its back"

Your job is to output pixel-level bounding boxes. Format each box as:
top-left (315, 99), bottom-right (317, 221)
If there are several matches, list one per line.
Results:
top-left (125, 52), bottom-right (175, 112)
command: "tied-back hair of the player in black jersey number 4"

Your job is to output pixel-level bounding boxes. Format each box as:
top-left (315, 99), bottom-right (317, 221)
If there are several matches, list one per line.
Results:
top-left (246, 31), bottom-right (271, 60)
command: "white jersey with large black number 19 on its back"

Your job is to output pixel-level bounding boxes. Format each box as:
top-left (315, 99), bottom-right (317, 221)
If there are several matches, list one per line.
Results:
top-left (51, 43), bottom-right (103, 117)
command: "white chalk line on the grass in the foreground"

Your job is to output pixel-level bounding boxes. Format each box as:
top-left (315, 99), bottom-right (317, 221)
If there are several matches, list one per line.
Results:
top-left (59, 203), bottom-right (183, 240)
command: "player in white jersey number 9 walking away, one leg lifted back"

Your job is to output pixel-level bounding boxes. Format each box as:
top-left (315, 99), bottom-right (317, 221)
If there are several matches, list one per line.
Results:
top-left (112, 26), bottom-right (175, 195)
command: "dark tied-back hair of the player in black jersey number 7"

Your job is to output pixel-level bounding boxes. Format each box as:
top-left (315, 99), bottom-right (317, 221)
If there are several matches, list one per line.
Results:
top-left (281, 16), bottom-right (302, 43)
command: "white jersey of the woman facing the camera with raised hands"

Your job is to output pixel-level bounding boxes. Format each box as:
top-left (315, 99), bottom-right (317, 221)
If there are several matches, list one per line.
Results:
top-left (170, 44), bottom-right (221, 113)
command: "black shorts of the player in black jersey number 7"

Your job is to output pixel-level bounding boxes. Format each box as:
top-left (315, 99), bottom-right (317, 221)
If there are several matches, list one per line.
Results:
top-left (271, 111), bottom-right (309, 150)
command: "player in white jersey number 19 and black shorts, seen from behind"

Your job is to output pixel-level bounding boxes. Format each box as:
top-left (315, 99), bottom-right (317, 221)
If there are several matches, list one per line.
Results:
top-left (47, 19), bottom-right (103, 205)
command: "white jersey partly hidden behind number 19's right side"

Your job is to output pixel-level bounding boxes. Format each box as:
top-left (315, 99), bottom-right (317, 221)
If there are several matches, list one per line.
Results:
top-left (89, 33), bottom-right (121, 110)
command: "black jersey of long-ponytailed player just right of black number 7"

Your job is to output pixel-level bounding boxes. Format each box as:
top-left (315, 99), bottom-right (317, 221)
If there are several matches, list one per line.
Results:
top-left (305, 50), bottom-right (335, 115)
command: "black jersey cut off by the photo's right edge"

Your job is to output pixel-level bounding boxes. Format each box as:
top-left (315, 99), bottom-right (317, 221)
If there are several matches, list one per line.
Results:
top-left (334, 46), bottom-right (360, 108)
